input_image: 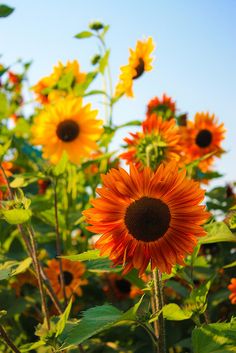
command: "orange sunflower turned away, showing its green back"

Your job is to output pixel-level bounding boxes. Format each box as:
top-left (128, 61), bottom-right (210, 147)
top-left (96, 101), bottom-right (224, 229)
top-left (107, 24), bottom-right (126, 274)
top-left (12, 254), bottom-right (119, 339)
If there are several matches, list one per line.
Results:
top-left (120, 114), bottom-right (182, 170)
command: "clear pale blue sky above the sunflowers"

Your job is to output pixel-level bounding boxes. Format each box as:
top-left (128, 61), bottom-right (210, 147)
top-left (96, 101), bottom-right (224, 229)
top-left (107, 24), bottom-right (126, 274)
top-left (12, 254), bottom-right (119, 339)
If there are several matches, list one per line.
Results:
top-left (0, 0), bottom-right (236, 186)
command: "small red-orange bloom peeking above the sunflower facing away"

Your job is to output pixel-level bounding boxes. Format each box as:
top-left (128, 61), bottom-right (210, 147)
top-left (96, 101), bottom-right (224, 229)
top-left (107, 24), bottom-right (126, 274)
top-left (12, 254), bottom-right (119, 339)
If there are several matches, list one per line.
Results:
top-left (147, 93), bottom-right (176, 120)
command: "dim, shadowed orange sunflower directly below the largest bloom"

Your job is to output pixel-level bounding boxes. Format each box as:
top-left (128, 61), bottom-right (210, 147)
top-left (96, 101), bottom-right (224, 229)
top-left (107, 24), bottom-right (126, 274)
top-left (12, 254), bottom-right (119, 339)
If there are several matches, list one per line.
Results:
top-left (103, 273), bottom-right (143, 300)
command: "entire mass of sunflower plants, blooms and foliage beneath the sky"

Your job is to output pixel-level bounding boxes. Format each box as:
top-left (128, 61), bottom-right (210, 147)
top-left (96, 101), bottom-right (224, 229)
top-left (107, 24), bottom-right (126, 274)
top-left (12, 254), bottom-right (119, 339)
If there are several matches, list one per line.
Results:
top-left (0, 4), bottom-right (236, 353)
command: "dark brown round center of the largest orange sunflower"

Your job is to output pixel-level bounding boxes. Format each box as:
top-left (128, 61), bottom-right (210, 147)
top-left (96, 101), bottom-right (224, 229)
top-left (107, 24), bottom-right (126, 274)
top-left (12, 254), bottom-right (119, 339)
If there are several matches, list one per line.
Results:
top-left (125, 196), bottom-right (171, 242)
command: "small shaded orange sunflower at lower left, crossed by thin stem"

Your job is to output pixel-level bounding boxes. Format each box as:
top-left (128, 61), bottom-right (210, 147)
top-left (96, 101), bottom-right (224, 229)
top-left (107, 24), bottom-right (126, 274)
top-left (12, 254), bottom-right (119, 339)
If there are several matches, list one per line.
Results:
top-left (45, 259), bottom-right (88, 299)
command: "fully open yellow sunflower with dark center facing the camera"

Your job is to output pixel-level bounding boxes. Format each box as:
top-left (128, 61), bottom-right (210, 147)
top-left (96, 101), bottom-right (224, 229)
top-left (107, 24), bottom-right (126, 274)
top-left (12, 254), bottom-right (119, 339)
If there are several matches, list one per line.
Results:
top-left (32, 97), bottom-right (102, 163)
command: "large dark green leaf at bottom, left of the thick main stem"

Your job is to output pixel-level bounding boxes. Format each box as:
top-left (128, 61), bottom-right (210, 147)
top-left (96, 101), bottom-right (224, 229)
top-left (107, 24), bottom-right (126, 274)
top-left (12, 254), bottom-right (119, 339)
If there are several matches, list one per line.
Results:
top-left (63, 304), bottom-right (122, 349)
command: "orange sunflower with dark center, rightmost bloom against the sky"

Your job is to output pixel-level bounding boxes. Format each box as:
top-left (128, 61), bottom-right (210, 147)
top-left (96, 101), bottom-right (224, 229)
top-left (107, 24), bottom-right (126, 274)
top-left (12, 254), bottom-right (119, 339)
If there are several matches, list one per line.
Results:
top-left (181, 113), bottom-right (225, 172)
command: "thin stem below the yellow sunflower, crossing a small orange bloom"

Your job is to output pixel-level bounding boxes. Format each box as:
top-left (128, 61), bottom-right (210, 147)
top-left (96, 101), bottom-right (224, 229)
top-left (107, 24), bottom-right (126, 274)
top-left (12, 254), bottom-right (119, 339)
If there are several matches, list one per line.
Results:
top-left (54, 180), bottom-right (67, 306)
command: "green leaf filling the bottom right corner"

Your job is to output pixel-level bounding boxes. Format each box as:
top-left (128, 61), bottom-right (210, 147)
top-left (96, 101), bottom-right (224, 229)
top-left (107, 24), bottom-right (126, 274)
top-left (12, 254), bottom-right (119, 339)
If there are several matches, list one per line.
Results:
top-left (192, 319), bottom-right (236, 353)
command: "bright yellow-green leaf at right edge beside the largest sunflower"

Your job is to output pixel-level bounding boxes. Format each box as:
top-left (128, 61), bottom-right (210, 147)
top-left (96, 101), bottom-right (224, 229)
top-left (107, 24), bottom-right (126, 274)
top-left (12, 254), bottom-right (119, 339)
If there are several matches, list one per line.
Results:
top-left (198, 222), bottom-right (236, 244)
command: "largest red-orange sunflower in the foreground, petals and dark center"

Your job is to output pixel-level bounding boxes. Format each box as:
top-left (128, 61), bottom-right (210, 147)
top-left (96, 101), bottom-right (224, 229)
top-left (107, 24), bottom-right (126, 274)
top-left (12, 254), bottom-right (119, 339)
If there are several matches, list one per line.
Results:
top-left (83, 162), bottom-right (209, 275)
